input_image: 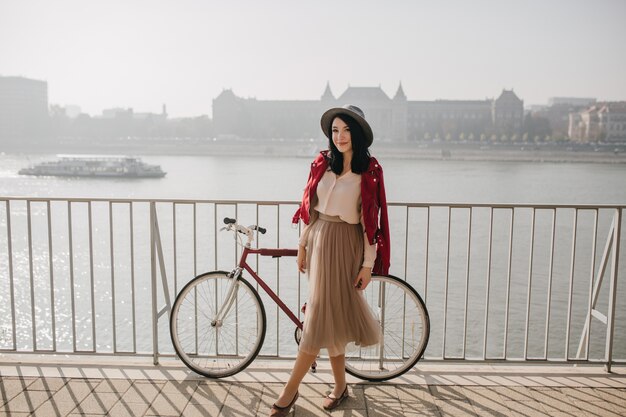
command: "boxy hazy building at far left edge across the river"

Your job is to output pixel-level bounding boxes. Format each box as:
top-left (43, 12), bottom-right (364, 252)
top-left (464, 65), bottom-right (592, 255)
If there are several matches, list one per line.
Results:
top-left (0, 77), bottom-right (49, 141)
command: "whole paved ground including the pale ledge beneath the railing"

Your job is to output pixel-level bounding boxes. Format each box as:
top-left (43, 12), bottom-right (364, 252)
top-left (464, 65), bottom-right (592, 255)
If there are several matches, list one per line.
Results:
top-left (0, 355), bottom-right (626, 417)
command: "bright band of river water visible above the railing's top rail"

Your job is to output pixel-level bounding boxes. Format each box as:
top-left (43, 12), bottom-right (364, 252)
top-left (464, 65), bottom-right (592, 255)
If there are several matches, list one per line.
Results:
top-left (0, 155), bottom-right (626, 204)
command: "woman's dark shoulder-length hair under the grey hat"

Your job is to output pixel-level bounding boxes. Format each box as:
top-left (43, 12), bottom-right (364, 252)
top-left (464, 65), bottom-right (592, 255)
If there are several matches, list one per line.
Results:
top-left (327, 114), bottom-right (370, 175)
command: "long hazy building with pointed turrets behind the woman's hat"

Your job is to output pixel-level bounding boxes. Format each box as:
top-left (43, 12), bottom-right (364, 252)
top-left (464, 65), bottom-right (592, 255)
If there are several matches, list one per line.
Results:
top-left (213, 84), bottom-right (524, 141)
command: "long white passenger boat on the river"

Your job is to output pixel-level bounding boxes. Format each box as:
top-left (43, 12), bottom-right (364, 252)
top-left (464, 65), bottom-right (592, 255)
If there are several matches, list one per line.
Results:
top-left (18, 155), bottom-right (165, 178)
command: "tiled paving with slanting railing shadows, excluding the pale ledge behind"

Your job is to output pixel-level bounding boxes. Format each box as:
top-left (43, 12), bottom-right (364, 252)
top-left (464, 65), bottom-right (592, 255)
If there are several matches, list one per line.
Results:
top-left (0, 376), bottom-right (626, 417)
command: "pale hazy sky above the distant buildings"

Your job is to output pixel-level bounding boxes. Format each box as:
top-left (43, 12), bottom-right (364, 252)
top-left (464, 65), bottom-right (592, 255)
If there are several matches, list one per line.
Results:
top-left (0, 0), bottom-right (626, 117)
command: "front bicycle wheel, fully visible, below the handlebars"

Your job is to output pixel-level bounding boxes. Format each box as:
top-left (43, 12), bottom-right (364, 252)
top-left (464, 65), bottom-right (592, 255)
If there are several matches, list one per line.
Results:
top-left (170, 271), bottom-right (266, 378)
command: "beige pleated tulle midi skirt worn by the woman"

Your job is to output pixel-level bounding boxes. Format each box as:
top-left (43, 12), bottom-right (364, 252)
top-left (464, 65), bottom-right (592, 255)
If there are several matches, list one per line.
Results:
top-left (300, 213), bottom-right (381, 357)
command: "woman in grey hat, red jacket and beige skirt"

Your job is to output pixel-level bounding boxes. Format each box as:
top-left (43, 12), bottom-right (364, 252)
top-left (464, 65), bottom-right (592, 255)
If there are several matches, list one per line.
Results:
top-left (270, 105), bottom-right (390, 416)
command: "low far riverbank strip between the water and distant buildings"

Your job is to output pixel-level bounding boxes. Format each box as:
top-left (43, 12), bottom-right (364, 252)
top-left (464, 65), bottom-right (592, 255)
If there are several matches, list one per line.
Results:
top-left (0, 138), bottom-right (626, 164)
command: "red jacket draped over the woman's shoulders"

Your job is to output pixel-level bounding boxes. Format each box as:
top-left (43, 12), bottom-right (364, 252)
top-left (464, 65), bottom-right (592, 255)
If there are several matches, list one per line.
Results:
top-left (293, 151), bottom-right (391, 275)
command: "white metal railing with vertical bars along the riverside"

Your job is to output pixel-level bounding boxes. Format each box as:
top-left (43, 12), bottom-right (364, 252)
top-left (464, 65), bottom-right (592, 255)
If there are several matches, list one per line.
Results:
top-left (0, 197), bottom-right (626, 369)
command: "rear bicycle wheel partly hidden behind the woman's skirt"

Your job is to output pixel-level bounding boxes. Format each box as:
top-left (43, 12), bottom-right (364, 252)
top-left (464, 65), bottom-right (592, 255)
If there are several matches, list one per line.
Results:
top-left (346, 275), bottom-right (430, 381)
